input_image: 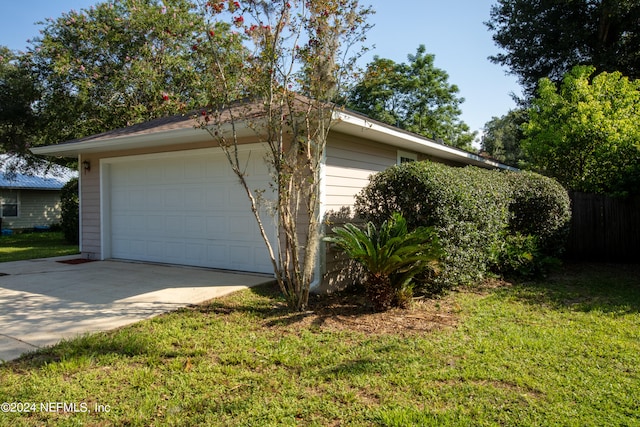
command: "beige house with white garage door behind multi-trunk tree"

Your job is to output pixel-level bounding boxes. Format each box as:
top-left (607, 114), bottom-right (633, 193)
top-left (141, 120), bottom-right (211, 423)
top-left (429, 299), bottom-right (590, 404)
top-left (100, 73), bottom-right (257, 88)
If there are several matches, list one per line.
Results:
top-left (32, 105), bottom-right (508, 286)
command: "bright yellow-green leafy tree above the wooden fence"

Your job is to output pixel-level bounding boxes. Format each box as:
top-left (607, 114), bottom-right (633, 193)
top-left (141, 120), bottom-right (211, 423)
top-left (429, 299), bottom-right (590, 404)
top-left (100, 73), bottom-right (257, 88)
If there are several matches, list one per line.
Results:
top-left (522, 66), bottom-right (640, 195)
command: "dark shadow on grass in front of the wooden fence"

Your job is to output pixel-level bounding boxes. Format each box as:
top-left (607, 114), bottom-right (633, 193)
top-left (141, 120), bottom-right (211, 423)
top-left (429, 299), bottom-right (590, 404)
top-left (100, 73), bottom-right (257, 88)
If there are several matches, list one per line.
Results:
top-left (496, 263), bottom-right (640, 314)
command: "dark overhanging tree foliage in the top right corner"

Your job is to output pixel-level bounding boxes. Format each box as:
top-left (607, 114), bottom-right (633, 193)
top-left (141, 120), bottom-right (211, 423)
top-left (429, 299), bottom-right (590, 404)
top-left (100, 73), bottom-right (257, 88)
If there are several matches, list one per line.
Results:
top-left (485, 0), bottom-right (640, 96)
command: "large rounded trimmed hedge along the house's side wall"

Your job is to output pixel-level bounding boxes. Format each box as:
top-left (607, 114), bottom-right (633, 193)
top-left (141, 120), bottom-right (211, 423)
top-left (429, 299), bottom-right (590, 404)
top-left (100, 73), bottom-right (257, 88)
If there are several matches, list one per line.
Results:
top-left (355, 162), bottom-right (570, 289)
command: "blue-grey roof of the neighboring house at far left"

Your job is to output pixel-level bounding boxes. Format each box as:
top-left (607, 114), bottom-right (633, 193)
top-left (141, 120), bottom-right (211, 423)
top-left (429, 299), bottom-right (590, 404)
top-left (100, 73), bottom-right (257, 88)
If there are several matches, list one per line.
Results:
top-left (0, 154), bottom-right (78, 190)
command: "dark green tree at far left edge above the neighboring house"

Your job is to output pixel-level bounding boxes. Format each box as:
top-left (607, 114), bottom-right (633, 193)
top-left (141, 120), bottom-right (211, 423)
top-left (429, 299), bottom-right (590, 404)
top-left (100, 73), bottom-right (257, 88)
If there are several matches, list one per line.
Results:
top-left (0, 46), bottom-right (39, 154)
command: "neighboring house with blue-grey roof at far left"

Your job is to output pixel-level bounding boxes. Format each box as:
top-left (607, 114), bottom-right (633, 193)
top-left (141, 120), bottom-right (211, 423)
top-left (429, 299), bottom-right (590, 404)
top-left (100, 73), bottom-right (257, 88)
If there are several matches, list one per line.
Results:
top-left (0, 155), bottom-right (78, 230)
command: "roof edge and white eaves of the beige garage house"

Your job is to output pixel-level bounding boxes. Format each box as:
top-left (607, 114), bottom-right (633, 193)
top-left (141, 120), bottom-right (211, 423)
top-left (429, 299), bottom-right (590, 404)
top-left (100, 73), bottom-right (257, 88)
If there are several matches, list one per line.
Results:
top-left (31, 102), bottom-right (517, 170)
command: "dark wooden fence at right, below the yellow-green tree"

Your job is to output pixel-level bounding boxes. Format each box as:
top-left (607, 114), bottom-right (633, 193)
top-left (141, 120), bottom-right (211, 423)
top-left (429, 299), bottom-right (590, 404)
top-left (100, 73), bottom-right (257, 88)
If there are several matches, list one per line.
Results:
top-left (566, 192), bottom-right (640, 263)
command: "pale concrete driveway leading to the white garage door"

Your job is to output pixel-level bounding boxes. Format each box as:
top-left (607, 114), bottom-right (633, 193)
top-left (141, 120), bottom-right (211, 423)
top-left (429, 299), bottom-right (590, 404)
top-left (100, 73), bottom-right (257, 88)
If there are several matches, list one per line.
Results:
top-left (0, 256), bottom-right (273, 363)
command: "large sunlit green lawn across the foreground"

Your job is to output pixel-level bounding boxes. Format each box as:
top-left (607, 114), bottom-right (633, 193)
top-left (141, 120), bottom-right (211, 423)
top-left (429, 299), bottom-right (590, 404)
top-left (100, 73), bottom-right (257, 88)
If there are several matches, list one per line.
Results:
top-left (0, 265), bottom-right (640, 426)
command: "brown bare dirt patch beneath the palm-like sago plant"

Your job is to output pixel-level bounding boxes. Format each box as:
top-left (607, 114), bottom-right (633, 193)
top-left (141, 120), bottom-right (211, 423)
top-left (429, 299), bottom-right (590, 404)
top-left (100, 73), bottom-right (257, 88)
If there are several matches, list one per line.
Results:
top-left (265, 293), bottom-right (461, 336)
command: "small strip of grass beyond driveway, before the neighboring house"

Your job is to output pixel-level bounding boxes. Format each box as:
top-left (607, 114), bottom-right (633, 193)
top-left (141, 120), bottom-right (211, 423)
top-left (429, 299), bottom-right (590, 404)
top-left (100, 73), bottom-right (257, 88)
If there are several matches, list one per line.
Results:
top-left (0, 231), bottom-right (78, 262)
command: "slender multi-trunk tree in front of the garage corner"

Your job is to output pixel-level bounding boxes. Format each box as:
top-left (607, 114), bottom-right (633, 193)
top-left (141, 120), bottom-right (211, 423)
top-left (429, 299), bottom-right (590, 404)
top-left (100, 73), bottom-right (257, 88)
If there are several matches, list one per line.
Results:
top-left (202, 0), bottom-right (370, 310)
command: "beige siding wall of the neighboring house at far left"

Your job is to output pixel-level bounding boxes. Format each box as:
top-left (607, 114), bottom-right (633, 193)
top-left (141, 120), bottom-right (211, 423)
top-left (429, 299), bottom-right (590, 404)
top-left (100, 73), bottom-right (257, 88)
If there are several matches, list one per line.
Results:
top-left (2, 190), bottom-right (60, 229)
